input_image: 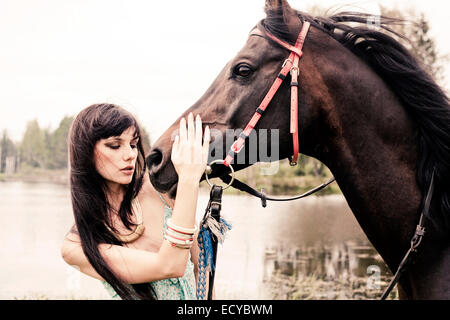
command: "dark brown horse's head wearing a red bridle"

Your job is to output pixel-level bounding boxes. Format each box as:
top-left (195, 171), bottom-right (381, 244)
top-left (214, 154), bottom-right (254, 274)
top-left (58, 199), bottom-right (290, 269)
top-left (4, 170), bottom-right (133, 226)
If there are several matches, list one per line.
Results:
top-left (147, 0), bottom-right (356, 196)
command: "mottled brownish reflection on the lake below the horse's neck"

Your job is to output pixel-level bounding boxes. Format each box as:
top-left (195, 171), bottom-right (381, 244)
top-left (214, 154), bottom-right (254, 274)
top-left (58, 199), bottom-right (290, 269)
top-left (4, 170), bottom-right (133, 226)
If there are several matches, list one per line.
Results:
top-left (263, 241), bottom-right (391, 299)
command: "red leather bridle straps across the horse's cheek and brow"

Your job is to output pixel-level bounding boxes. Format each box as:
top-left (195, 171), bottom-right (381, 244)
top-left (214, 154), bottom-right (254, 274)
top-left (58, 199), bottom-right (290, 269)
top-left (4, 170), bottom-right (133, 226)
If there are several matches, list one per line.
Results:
top-left (223, 21), bottom-right (310, 167)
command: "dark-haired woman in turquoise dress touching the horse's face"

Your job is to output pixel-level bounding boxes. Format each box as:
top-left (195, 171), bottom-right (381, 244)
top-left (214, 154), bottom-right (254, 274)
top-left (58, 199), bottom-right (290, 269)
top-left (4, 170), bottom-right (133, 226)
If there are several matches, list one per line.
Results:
top-left (61, 104), bottom-right (210, 299)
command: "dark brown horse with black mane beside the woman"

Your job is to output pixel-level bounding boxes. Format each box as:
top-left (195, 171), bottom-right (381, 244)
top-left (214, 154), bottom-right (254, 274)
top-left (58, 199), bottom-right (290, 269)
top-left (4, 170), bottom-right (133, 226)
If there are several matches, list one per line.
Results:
top-left (147, 0), bottom-right (450, 299)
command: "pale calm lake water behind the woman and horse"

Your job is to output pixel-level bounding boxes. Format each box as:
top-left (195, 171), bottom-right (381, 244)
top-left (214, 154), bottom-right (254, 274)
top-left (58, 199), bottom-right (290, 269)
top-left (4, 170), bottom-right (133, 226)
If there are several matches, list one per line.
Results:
top-left (0, 182), bottom-right (395, 299)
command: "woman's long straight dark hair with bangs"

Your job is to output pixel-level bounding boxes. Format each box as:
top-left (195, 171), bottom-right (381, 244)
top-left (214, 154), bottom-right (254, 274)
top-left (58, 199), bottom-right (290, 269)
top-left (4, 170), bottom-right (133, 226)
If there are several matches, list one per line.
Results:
top-left (68, 103), bottom-right (155, 300)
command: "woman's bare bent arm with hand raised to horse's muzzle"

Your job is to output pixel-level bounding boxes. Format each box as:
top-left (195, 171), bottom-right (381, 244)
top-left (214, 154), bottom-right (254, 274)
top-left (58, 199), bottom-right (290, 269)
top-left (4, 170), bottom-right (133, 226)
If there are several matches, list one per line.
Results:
top-left (61, 115), bottom-right (210, 283)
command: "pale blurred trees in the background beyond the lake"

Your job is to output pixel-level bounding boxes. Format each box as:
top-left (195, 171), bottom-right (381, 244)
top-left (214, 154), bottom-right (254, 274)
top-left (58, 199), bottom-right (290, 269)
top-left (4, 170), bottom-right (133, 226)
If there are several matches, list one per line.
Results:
top-left (0, 6), bottom-right (442, 176)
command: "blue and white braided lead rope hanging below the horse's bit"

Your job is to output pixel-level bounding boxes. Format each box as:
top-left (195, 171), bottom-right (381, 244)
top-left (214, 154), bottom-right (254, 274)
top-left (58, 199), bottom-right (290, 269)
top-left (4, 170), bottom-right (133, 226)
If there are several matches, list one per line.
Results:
top-left (197, 185), bottom-right (231, 300)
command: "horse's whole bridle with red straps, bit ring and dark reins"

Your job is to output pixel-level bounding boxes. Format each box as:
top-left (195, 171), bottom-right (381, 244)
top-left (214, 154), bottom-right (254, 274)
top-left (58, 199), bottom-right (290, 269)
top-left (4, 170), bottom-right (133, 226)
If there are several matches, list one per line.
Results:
top-left (205, 21), bottom-right (435, 300)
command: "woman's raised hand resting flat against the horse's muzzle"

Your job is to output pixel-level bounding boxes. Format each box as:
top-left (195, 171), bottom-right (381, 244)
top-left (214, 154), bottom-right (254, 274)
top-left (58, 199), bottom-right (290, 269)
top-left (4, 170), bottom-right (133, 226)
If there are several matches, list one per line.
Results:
top-left (171, 113), bottom-right (211, 181)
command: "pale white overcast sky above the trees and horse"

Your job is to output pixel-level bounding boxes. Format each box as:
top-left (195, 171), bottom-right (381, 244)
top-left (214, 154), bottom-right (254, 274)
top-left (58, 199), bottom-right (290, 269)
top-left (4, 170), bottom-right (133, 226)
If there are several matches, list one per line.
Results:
top-left (0, 0), bottom-right (450, 141)
